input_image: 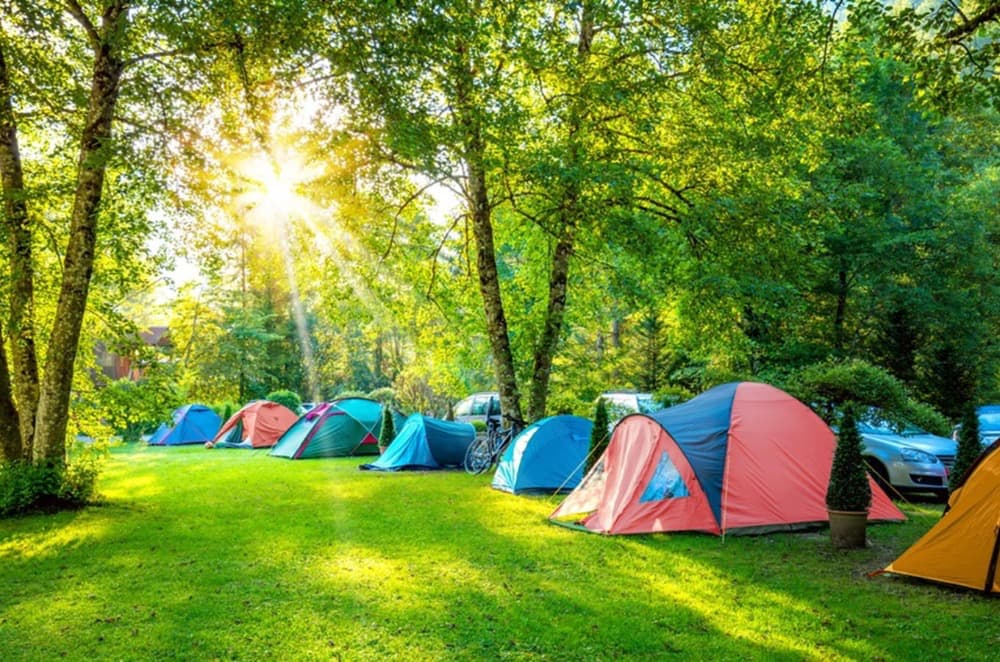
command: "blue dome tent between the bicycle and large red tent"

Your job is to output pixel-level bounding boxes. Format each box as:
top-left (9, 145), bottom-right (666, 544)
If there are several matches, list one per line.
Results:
top-left (493, 415), bottom-right (594, 494)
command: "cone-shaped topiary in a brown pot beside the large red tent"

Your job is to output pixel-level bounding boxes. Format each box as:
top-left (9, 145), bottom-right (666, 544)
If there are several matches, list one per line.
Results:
top-left (826, 404), bottom-right (872, 549)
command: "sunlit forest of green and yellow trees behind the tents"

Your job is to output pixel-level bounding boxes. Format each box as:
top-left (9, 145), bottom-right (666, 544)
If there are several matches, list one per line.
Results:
top-left (0, 0), bottom-right (1000, 462)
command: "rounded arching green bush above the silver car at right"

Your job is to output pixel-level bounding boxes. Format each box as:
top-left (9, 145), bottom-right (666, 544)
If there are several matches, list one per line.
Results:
top-left (783, 359), bottom-right (950, 435)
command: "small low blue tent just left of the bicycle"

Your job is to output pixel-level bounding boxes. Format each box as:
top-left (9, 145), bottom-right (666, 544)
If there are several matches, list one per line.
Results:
top-left (361, 414), bottom-right (476, 471)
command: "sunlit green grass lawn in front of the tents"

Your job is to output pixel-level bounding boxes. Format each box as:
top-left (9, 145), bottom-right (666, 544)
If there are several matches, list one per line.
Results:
top-left (0, 447), bottom-right (1000, 660)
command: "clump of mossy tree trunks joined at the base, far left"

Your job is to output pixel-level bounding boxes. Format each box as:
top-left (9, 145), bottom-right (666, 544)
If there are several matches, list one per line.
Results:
top-left (0, 0), bottom-right (129, 464)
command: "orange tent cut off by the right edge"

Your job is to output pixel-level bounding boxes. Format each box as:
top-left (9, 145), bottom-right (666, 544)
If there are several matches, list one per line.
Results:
top-left (882, 441), bottom-right (1000, 593)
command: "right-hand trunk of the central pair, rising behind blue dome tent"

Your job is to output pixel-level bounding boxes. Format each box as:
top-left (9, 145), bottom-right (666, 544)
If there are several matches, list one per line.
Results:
top-left (528, 2), bottom-right (594, 421)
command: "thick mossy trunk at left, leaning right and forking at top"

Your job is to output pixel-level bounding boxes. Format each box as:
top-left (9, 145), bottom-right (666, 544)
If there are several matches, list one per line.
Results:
top-left (34, 0), bottom-right (128, 463)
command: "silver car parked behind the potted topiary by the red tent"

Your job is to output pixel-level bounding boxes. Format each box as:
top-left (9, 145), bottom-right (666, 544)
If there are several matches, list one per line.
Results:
top-left (858, 412), bottom-right (958, 500)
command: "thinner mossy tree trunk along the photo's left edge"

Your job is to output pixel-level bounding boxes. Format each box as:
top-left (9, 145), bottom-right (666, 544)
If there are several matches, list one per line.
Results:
top-left (0, 39), bottom-right (38, 459)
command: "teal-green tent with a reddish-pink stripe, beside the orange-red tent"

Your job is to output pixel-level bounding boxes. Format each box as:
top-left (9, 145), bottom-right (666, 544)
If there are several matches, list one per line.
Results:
top-left (270, 398), bottom-right (395, 460)
